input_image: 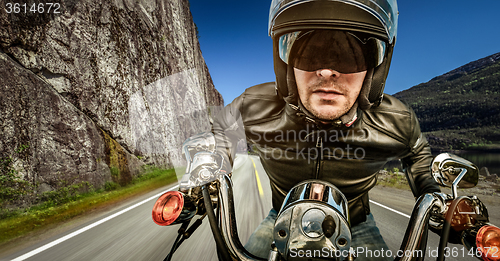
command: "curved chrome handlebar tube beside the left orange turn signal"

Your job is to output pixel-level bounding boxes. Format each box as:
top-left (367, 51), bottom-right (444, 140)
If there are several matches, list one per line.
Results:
top-left (217, 175), bottom-right (264, 261)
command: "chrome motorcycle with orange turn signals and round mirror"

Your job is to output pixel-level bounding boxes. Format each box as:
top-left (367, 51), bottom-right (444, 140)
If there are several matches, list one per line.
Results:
top-left (152, 133), bottom-right (500, 261)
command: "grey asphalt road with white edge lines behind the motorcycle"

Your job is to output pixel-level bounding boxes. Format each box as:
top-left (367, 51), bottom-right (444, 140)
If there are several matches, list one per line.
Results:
top-left (1, 156), bottom-right (496, 261)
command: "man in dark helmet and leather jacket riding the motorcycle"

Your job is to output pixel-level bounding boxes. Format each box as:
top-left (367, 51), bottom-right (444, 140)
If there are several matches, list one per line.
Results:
top-left (213, 0), bottom-right (439, 260)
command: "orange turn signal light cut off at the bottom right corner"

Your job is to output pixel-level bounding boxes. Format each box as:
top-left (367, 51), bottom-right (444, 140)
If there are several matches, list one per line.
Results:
top-left (476, 225), bottom-right (500, 261)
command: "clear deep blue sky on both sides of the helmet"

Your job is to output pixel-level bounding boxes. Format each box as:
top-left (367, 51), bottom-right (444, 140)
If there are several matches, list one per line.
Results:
top-left (190, 0), bottom-right (500, 104)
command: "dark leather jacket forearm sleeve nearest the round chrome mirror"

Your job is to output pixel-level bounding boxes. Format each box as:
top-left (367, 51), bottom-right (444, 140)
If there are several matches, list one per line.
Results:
top-left (401, 105), bottom-right (440, 198)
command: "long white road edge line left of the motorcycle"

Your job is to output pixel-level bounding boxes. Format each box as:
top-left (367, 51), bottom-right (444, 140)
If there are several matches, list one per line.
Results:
top-left (12, 185), bottom-right (179, 261)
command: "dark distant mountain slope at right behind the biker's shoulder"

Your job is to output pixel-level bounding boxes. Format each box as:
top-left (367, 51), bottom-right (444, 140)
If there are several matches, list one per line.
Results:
top-left (394, 53), bottom-right (500, 149)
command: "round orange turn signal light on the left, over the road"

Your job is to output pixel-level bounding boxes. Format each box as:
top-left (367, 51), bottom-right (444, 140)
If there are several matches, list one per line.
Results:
top-left (153, 191), bottom-right (184, 226)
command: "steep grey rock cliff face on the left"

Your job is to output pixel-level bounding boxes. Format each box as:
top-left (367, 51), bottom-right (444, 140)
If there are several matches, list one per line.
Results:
top-left (0, 0), bottom-right (223, 203)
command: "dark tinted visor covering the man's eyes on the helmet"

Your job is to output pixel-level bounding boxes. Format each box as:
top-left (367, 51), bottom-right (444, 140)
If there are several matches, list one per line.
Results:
top-left (278, 30), bottom-right (386, 73)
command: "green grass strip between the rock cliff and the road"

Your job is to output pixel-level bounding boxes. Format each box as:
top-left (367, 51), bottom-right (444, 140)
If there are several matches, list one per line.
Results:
top-left (0, 169), bottom-right (177, 245)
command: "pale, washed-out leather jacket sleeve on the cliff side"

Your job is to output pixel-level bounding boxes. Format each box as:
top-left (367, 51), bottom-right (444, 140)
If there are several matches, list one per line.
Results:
top-left (212, 94), bottom-right (246, 173)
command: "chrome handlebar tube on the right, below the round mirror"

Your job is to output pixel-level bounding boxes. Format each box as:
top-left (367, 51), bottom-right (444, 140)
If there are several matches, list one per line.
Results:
top-left (394, 193), bottom-right (446, 261)
